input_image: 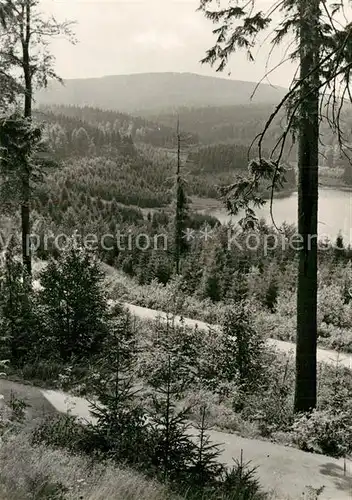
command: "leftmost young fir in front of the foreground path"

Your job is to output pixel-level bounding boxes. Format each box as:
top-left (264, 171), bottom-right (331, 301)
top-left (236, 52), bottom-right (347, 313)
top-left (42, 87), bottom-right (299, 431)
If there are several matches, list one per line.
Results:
top-left (89, 306), bottom-right (148, 467)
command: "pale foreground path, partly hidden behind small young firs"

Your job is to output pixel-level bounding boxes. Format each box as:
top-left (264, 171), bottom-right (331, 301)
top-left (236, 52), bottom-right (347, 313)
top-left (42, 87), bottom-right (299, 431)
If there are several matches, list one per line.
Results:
top-left (0, 380), bottom-right (352, 500)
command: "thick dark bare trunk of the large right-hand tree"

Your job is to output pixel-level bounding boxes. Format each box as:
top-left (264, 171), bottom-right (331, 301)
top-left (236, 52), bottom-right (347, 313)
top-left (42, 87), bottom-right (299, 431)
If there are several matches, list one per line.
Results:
top-left (295, 0), bottom-right (320, 412)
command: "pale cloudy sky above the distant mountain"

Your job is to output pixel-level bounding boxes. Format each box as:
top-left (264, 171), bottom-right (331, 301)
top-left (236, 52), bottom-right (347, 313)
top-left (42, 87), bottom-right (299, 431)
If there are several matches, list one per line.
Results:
top-left (42, 0), bottom-right (293, 86)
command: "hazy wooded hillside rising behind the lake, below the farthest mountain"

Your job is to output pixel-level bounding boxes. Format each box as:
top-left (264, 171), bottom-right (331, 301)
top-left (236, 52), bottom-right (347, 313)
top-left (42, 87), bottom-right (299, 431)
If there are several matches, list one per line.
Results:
top-left (141, 103), bottom-right (352, 179)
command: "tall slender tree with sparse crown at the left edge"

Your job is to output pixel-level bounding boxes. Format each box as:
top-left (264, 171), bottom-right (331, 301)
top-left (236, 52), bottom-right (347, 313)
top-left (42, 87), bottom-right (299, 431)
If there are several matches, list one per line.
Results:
top-left (0, 0), bottom-right (72, 276)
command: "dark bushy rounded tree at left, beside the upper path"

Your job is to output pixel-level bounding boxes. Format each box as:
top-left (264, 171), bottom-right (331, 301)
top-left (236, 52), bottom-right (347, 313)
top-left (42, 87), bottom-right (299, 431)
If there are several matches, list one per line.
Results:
top-left (40, 242), bottom-right (107, 360)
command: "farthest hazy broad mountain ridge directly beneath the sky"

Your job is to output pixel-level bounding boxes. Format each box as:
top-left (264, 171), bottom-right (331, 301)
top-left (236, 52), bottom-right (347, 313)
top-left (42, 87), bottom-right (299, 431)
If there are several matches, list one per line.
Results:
top-left (36, 73), bottom-right (285, 112)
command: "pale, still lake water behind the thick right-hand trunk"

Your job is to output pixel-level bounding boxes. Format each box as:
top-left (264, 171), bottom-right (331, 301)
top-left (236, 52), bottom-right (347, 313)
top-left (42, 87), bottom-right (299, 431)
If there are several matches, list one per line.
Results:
top-left (211, 188), bottom-right (352, 245)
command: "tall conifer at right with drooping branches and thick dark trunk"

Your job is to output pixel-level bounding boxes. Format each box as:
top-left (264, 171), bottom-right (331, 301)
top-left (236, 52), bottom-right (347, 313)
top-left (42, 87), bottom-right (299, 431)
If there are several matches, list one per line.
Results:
top-left (199, 0), bottom-right (352, 412)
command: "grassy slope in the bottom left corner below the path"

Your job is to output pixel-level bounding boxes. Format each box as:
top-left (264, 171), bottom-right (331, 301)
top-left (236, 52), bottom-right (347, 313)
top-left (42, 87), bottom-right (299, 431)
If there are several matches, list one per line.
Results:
top-left (0, 433), bottom-right (177, 500)
